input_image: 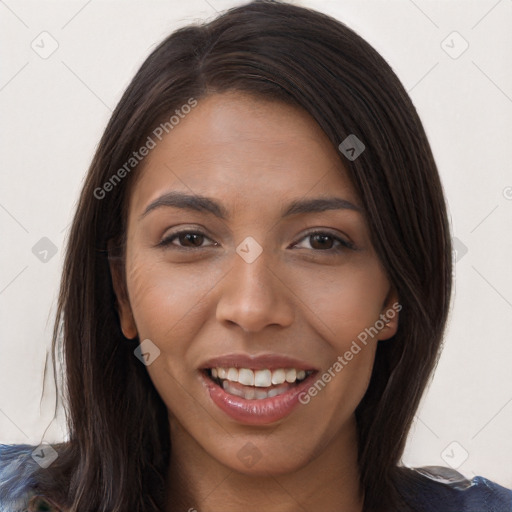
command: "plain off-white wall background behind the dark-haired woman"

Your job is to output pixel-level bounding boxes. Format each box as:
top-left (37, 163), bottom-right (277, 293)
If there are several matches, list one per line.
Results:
top-left (0, 0), bottom-right (512, 488)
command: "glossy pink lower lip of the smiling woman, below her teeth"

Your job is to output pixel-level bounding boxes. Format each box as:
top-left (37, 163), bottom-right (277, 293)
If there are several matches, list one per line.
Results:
top-left (201, 372), bottom-right (316, 425)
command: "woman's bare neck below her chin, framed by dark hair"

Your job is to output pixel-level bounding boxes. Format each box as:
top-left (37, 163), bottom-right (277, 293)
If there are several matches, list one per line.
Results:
top-left (167, 420), bottom-right (363, 512)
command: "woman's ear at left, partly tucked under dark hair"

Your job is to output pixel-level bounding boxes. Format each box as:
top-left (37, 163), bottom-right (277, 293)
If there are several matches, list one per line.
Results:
top-left (108, 240), bottom-right (137, 340)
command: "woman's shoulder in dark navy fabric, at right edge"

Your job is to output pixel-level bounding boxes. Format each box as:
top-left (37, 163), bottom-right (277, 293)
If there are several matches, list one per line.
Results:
top-left (399, 466), bottom-right (512, 512)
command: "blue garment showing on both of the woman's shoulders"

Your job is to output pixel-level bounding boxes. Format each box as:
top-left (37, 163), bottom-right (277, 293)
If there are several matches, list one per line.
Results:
top-left (0, 444), bottom-right (512, 512)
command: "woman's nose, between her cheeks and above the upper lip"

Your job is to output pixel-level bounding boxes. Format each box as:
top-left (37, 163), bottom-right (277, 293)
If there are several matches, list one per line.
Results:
top-left (216, 251), bottom-right (294, 332)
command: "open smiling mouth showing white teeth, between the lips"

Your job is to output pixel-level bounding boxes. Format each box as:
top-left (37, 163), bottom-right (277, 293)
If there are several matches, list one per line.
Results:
top-left (203, 367), bottom-right (315, 400)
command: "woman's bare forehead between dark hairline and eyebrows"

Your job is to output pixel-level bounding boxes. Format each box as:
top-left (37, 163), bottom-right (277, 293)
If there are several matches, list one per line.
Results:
top-left (130, 92), bottom-right (359, 216)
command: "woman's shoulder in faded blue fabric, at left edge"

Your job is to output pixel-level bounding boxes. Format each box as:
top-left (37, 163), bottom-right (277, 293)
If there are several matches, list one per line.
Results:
top-left (0, 444), bottom-right (61, 512)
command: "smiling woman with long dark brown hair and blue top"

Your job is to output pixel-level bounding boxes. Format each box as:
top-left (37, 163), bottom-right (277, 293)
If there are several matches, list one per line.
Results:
top-left (0, 1), bottom-right (512, 512)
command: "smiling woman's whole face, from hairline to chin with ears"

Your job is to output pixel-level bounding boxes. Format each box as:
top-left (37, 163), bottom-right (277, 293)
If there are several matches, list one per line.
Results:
top-left (115, 92), bottom-right (397, 474)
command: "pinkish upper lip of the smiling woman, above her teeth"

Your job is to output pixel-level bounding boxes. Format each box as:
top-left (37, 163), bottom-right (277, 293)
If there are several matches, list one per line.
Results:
top-left (201, 353), bottom-right (316, 370)
